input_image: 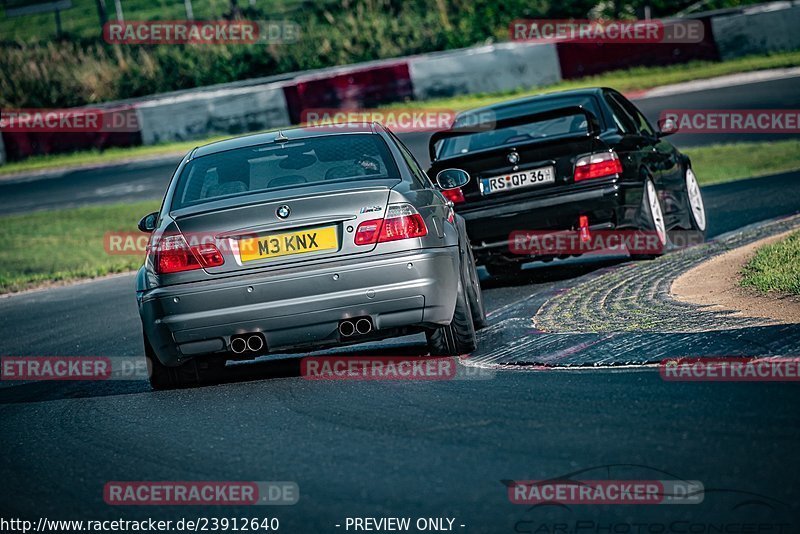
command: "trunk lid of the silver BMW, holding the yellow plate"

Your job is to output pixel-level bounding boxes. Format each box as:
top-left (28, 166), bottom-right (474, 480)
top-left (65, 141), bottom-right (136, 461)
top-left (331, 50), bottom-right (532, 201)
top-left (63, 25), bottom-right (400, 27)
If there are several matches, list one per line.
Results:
top-left (172, 179), bottom-right (397, 274)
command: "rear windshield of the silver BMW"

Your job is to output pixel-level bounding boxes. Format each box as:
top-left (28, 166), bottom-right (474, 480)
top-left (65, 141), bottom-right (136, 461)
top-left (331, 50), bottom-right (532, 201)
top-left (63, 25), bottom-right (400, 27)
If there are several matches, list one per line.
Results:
top-left (172, 134), bottom-right (400, 209)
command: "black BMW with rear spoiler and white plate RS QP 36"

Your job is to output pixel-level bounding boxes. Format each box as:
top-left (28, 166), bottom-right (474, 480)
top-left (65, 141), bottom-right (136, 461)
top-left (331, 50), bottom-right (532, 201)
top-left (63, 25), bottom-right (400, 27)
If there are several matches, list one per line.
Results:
top-left (428, 88), bottom-right (706, 274)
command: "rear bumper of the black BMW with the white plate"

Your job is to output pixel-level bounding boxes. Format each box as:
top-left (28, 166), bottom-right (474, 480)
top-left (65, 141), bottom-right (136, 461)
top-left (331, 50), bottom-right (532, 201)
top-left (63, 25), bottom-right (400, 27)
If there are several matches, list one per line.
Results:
top-left (458, 182), bottom-right (625, 263)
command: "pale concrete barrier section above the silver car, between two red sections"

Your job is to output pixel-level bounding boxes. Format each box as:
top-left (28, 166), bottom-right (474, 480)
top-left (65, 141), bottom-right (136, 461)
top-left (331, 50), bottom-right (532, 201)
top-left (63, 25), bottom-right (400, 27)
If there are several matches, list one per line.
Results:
top-left (136, 83), bottom-right (290, 145)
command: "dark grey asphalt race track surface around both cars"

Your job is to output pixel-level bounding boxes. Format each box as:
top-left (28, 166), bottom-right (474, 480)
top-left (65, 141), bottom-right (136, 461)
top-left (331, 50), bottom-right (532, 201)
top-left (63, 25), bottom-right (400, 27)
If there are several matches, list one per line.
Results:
top-left (0, 78), bottom-right (800, 533)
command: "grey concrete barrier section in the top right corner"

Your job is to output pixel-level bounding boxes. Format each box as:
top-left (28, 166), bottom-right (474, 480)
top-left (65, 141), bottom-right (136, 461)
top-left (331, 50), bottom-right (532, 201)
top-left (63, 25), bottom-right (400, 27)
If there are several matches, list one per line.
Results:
top-left (711, 2), bottom-right (800, 59)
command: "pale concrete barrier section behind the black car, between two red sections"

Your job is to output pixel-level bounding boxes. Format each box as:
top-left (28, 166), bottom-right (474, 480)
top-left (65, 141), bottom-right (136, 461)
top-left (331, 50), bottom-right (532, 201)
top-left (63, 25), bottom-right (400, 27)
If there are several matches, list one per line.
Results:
top-left (409, 43), bottom-right (561, 100)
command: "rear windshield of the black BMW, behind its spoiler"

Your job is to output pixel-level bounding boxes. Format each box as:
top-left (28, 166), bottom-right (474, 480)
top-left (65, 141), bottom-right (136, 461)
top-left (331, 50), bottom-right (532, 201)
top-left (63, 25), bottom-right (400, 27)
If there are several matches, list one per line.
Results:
top-left (438, 96), bottom-right (600, 158)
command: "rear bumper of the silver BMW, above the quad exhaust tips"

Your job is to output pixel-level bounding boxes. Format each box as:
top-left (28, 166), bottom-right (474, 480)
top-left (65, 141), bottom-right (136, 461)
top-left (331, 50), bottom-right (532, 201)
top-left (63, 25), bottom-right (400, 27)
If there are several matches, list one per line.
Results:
top-left (139, 247), bottom-right (459, 365)
